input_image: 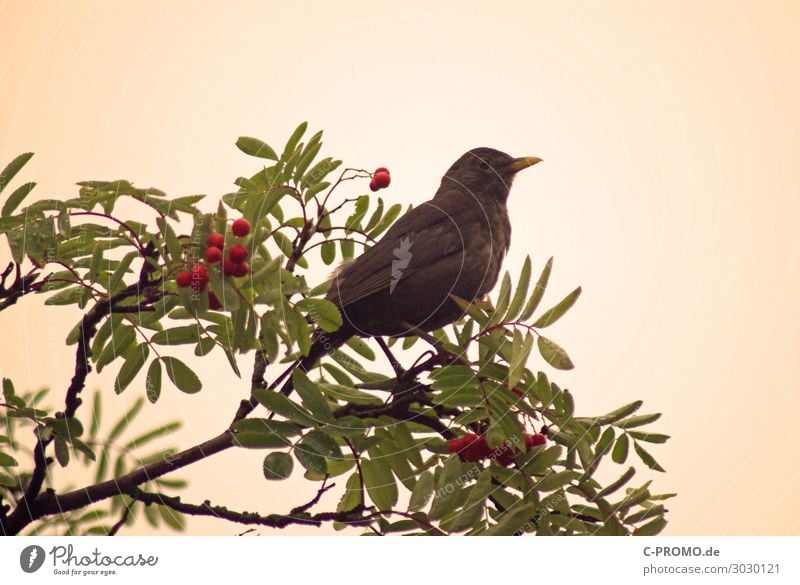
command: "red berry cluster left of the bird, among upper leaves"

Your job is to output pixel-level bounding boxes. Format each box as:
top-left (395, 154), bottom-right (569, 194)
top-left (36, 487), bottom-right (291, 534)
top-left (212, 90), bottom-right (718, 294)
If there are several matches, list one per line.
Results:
top-left (175, 217), bottom-right (255, 310)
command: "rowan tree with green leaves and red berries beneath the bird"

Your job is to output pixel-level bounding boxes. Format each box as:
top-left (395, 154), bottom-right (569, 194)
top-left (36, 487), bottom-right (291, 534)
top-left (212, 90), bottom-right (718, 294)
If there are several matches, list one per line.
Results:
top-left (0, 123), bottom-right (674, 535)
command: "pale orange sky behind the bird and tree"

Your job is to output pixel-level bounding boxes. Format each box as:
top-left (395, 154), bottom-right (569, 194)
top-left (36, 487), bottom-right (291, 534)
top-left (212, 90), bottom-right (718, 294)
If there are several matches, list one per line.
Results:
top-left (0, 0), bottom-right (800, 534)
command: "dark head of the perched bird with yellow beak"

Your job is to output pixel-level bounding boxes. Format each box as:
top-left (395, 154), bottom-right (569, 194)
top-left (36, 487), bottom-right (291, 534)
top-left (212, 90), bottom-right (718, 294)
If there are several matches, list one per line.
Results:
top-left (442, 146), bottom-right (542, 202)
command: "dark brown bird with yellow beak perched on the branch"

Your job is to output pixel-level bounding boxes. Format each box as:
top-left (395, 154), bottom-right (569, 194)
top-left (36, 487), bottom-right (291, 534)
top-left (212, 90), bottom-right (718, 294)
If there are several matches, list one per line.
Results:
top-left (282, 147), bottom-right (542, 394)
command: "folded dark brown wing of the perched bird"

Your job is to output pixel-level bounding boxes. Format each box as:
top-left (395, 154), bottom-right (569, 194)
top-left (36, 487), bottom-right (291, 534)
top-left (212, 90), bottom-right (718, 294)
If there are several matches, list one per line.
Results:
top-left (328, 201), bottom-right (472, 307)
